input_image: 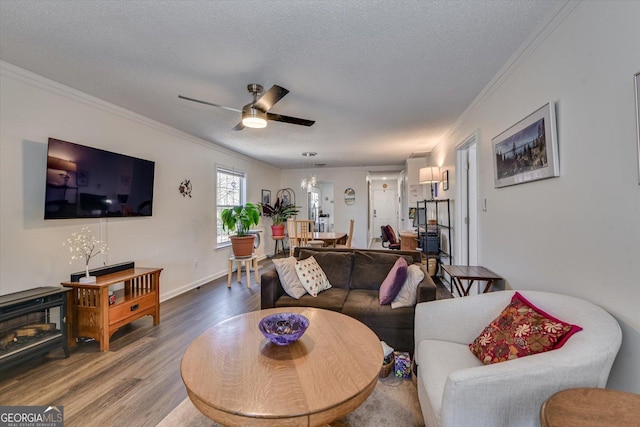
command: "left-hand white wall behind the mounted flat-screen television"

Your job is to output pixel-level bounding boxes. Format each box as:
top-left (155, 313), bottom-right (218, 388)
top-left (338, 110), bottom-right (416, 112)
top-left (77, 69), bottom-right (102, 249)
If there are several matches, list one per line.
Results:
top-left (0, 62), bottom-right (280, 299)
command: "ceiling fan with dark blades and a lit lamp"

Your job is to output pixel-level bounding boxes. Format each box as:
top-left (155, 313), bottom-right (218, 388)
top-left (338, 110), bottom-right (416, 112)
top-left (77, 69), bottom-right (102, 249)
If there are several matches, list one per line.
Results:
top-left (178, 83), bottom-right (315, 130)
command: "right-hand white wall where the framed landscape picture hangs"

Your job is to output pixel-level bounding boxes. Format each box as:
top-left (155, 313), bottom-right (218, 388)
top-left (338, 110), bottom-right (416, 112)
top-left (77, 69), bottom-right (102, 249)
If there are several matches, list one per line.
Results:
top-left (433, 1), bottom-right (640, 393)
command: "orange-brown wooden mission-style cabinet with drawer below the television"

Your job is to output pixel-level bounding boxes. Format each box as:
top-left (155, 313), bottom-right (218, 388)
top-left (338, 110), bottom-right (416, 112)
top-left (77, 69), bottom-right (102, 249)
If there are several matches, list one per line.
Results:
top-left (62, 268), bottom-right (162, 351)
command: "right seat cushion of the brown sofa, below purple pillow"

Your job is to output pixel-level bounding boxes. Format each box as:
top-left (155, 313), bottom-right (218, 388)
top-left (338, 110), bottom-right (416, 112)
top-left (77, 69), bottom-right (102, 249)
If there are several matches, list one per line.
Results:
top-left (342, 289), bottom-right (414, 329)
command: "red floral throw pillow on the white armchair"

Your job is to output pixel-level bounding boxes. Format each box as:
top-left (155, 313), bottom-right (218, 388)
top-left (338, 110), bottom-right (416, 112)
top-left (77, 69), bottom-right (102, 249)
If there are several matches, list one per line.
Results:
top-left (469, 292), bottom-right (582, 365)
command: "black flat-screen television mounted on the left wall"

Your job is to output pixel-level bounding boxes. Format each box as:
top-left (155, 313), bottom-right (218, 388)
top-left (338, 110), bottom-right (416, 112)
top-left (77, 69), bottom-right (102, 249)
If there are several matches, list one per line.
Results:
top-left (44, 138), bottom-right (155, 219)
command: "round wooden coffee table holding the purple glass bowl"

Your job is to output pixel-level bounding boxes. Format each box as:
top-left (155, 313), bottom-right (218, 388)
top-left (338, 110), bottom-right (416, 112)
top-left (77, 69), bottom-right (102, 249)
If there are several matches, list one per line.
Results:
top-left (181, 307), bottom-right (383, 426)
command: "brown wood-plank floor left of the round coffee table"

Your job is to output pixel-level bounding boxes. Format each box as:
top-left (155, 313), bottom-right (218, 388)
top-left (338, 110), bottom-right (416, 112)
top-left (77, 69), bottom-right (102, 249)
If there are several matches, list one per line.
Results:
top-left (0, 259), bottom-right (273, 426)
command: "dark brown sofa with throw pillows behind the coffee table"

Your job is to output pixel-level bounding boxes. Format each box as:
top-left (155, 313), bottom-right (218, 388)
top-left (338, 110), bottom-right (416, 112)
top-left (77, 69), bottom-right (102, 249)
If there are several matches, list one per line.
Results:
top-left (260, 248), bottom-right (436, 352)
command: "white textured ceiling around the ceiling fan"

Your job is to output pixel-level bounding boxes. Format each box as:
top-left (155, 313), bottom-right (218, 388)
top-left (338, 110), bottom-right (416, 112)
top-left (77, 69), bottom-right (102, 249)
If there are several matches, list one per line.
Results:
top-left (0, 0), bottom-right (565, 168)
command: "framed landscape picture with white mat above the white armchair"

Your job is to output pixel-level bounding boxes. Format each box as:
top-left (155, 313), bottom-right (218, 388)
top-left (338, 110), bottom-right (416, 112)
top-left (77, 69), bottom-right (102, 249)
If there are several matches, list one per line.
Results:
top-left (491, 102), bottom-right (560, 188)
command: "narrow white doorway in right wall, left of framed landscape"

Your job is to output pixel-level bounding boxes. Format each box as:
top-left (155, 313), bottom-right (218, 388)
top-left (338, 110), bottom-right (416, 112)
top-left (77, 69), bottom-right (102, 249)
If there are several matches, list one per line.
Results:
top-left (456, 131), bottom-right (478, 272)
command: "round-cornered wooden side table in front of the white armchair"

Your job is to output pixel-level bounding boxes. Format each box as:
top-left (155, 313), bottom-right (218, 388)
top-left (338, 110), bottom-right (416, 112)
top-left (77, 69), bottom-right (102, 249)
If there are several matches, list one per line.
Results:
top-left (540, 388), bottom-right (640, 427)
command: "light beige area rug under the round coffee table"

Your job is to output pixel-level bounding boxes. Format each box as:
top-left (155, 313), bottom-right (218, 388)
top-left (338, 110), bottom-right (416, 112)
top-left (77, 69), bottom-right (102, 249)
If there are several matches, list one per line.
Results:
top-left (158, 376), bottom-right (424, 427)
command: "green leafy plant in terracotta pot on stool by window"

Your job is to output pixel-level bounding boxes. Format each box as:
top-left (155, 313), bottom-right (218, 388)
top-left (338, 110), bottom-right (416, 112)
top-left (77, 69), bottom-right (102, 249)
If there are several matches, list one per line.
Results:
top-left (220, 203), bottom-right (260, 257)
